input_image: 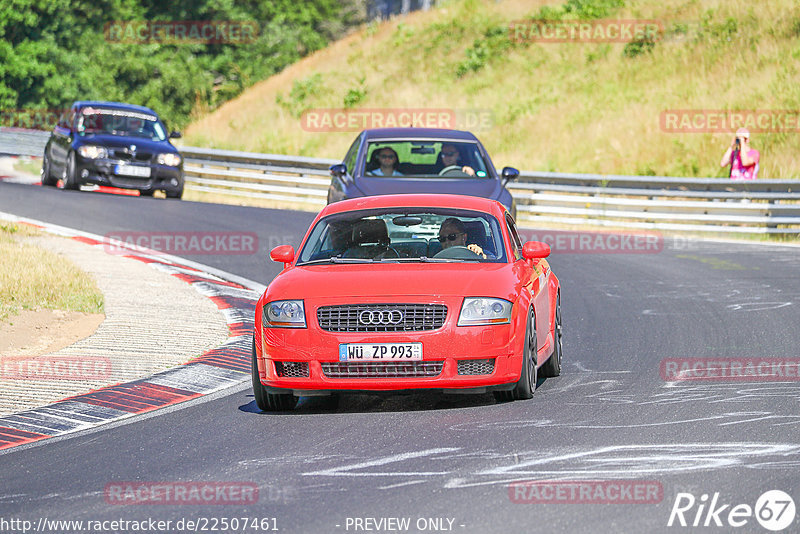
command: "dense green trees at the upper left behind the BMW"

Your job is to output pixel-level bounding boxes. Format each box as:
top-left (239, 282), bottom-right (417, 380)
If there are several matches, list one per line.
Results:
top-left (0, 0), bottom-right (369, 128)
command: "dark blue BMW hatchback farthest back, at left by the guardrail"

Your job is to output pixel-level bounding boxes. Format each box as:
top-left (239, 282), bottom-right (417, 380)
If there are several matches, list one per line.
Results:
top-left (42, 101), bottom-right (183, 198)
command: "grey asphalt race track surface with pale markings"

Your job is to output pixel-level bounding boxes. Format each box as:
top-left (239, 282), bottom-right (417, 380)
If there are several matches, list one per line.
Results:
top-left (0, 183), bottom-right (800, 533)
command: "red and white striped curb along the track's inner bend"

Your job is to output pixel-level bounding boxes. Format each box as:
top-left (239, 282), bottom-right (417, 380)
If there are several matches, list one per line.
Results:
top-left (0, 219), bottom-right (259, 450)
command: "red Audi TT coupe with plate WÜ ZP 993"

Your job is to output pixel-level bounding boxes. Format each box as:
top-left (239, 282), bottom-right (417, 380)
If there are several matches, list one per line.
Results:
top-left (252, 195), bottom-right (561, 411)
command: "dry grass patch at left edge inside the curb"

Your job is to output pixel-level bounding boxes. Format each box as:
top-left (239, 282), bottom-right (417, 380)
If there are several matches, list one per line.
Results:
top-left (0, 223), bottom-right (103, 321)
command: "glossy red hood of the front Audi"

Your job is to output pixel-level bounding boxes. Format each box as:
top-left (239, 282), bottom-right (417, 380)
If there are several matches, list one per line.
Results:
top-left (267, 262), bottom-right (521, 301)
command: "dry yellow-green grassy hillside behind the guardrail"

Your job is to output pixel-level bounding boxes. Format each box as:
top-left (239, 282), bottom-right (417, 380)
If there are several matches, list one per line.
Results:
top-left (186, 0), bottom-right (800, 178)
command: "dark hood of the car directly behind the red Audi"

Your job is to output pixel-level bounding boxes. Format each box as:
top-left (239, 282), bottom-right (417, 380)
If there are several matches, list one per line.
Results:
top-left (354, 176), bottom-right (502, 200)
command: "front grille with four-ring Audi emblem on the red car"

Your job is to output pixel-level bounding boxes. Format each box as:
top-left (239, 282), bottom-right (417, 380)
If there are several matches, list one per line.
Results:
top-left (317, 304), bottom-right (447, 332)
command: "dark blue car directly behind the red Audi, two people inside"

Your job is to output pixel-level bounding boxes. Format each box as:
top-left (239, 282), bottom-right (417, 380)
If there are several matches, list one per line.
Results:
top-left (328, 128), bottom-right (519, 216)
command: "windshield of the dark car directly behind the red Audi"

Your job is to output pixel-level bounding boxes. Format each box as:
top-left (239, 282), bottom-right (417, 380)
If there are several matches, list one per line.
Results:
top-left (359, 140), bottom-right (491, 180)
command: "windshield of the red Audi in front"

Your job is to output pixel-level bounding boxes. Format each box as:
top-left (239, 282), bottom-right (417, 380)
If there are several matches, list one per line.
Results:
top-left (297, 208), bottom-right (506, 265)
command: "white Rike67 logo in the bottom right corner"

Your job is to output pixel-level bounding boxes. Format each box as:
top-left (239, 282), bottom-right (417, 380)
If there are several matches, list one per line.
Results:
top-left (667, 490), bottom-right (796, 532)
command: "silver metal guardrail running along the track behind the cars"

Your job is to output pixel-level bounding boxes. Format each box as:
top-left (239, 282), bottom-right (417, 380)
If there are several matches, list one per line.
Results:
top-left (0, 129), bottom-right (800, 235)
